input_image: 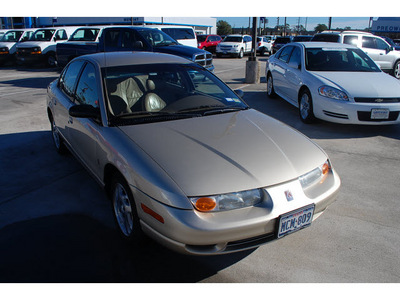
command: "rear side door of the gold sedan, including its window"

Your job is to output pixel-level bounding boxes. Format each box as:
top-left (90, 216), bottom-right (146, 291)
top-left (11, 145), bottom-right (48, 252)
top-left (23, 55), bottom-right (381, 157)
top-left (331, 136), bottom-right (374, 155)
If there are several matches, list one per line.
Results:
top-left (51, 60), bottom-right (84, 144)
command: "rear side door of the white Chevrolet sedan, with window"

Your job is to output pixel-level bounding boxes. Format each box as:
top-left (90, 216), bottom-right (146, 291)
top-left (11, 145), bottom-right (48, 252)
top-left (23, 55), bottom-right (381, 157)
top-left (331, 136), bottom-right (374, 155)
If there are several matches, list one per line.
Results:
top-left (272, 46), bottom-right (293, 99)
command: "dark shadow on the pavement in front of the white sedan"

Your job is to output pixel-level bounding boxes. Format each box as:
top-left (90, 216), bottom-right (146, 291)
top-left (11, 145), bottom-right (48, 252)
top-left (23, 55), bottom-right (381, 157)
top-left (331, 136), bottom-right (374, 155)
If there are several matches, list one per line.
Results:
top-left (243, 90), bottom-right (400, 140)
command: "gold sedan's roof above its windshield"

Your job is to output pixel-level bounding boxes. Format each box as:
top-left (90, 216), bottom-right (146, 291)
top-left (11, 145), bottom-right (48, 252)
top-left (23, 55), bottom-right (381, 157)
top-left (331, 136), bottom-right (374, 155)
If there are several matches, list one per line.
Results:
top-left (77, 51), bottom-right (192, 68)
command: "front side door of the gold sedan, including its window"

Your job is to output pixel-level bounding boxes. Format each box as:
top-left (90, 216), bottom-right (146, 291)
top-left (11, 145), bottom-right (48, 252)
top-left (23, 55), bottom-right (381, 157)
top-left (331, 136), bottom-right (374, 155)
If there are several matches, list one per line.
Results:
top-left (68, 63), bottom-right (101, 174)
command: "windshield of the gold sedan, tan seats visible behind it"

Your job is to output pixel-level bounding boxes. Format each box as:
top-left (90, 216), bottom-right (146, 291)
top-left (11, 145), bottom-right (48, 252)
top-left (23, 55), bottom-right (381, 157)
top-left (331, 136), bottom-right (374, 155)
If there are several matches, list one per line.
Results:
top-left (102, 64), bottom-right (248, 125)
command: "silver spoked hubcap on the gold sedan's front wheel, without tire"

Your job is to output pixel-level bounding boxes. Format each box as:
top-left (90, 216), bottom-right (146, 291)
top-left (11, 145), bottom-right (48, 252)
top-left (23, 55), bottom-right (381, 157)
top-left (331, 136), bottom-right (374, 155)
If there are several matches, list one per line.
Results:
top-left (113, 183), bottom-right (133, 236)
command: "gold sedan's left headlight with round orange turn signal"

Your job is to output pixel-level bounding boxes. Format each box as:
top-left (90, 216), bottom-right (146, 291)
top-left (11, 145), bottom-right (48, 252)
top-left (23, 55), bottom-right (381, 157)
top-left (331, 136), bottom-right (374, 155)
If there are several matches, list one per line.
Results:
top-left (190, 189), bottom-right (263, 212)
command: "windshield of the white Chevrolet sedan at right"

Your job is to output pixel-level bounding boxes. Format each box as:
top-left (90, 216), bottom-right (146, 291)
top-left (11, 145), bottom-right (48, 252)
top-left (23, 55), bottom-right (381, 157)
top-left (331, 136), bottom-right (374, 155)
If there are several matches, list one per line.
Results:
top-left (306, 48), bottom-right (380, 72)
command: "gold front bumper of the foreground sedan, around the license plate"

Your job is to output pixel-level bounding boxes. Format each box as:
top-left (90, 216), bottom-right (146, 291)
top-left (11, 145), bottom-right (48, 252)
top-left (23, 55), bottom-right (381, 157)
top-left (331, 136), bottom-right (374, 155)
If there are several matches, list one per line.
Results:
top-left (132, 171), bottom-right (340, 255)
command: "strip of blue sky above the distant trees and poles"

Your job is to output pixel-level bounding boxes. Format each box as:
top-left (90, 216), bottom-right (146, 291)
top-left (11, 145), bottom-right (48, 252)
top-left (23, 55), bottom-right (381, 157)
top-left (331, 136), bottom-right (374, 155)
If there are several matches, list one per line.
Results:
top-left (216, 16), bottom-right (377, 30)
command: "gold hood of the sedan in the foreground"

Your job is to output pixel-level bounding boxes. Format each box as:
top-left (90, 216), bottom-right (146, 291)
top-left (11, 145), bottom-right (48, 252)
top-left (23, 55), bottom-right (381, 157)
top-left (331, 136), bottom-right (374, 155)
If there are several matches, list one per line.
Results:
top-left (120, 109), bottom-right (327, 196)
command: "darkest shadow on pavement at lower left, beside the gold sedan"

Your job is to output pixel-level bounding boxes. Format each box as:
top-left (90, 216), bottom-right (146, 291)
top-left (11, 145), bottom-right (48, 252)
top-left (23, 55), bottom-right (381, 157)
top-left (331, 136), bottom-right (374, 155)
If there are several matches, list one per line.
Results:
top-left (0, 215), bottom-right (252, 283)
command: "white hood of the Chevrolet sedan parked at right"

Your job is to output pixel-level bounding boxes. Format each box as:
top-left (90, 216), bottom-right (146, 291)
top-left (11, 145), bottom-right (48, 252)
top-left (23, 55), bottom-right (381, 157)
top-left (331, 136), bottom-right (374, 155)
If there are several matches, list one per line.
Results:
top-left (311, 72), bottom-right (400, 98)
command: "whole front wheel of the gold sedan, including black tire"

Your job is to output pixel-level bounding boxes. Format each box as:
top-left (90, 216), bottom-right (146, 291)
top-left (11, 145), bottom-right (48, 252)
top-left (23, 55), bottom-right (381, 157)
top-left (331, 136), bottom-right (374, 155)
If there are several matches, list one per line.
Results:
top-left (110, 174), bottom-right (144, 242)
